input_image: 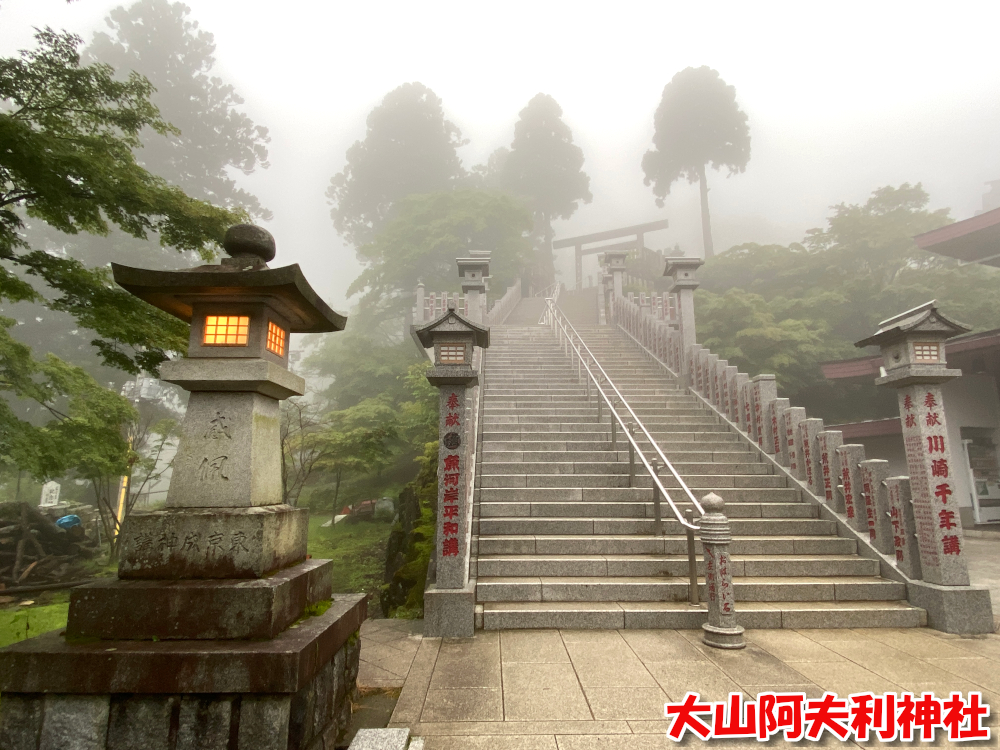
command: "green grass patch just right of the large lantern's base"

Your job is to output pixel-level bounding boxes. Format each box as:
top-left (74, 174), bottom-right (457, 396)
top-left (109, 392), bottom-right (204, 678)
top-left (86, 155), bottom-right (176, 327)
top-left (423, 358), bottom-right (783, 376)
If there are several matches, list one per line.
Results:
top-left (309, 514), bottom-right (392, 594)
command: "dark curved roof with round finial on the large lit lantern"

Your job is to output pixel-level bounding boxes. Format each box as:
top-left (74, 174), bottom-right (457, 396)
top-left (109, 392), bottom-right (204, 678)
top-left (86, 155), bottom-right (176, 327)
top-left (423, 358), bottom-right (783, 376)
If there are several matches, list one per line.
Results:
top-left (111, 224), bottom-right (347, 333)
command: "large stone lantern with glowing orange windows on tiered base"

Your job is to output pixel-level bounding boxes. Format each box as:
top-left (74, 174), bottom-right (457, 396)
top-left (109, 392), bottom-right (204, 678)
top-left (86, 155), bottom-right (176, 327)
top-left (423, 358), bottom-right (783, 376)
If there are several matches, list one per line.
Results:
top-left (0, 225), bottom-right (366, 750)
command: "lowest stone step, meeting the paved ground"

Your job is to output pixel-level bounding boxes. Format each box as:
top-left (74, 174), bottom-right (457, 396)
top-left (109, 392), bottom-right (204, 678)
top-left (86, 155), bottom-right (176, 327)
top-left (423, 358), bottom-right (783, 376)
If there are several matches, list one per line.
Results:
top-left (483, 600), bottom-right (927, 630)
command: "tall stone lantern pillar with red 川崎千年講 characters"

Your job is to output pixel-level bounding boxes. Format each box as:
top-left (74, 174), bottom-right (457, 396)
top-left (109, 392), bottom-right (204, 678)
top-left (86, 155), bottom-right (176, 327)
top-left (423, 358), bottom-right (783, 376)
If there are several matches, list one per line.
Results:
top-left (855, 300), bottom-right (993, 633)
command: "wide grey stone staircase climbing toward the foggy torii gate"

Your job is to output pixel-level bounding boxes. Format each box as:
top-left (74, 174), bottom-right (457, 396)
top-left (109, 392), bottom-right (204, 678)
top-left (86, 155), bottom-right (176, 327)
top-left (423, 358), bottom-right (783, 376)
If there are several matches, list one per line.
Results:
top-left (476, 308), bottom-right (926, 630)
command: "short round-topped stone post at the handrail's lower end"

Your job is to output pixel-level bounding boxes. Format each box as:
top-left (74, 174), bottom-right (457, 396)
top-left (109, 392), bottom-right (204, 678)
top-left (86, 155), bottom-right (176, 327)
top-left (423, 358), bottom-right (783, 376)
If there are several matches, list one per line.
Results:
top-left (699, 492), bottom-right (746, 649)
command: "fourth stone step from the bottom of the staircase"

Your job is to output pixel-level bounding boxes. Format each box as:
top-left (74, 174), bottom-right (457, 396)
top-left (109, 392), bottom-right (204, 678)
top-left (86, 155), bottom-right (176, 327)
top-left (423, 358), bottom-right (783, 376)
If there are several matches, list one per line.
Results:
top-left (479, 534), bottom-right (857, 556)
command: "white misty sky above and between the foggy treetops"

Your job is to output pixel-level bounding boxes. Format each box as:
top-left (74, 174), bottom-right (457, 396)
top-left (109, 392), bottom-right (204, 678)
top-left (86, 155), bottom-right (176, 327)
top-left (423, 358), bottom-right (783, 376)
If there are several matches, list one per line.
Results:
top-left (0, 0), bottom-right (1000, 309)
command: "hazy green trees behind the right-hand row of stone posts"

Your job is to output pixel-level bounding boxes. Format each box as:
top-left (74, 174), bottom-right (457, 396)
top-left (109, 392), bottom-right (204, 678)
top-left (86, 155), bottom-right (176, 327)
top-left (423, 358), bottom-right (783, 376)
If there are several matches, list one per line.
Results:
top-left (695, 184), bottom-right (1000, 420)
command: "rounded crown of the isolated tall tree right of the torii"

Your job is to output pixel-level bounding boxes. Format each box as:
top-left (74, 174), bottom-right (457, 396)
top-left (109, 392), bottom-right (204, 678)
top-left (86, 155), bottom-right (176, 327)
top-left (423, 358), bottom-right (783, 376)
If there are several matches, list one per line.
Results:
top-left (642, 65), bottom-right (750, 206)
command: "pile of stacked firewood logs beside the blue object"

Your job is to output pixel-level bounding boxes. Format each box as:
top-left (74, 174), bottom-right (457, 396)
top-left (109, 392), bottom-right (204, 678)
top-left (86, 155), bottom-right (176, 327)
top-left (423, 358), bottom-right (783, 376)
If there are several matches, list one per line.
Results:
top-left (0, 503), bottom-right (98, 591)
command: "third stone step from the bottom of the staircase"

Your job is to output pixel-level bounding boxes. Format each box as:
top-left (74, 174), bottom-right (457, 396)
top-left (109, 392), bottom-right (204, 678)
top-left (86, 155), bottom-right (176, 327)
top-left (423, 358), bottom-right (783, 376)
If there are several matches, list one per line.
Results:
top-left (478, 554), bottom-right (879, 578)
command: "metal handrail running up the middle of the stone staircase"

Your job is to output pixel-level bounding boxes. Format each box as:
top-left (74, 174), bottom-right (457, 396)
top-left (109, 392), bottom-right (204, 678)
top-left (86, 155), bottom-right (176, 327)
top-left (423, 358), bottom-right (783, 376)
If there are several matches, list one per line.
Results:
top-left (544, 298), bottom-right (705, 604)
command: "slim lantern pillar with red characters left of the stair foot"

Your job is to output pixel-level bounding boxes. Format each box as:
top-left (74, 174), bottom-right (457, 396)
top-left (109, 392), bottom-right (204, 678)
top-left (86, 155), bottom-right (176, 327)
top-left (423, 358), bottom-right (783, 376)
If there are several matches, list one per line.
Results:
top-left (414, 301), bottom-right (490, 637)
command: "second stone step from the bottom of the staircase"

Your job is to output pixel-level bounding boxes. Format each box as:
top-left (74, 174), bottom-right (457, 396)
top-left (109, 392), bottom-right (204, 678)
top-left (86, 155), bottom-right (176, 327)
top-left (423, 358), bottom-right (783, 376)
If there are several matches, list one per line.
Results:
top-left (476, 576), bottom-right (906, 608)
